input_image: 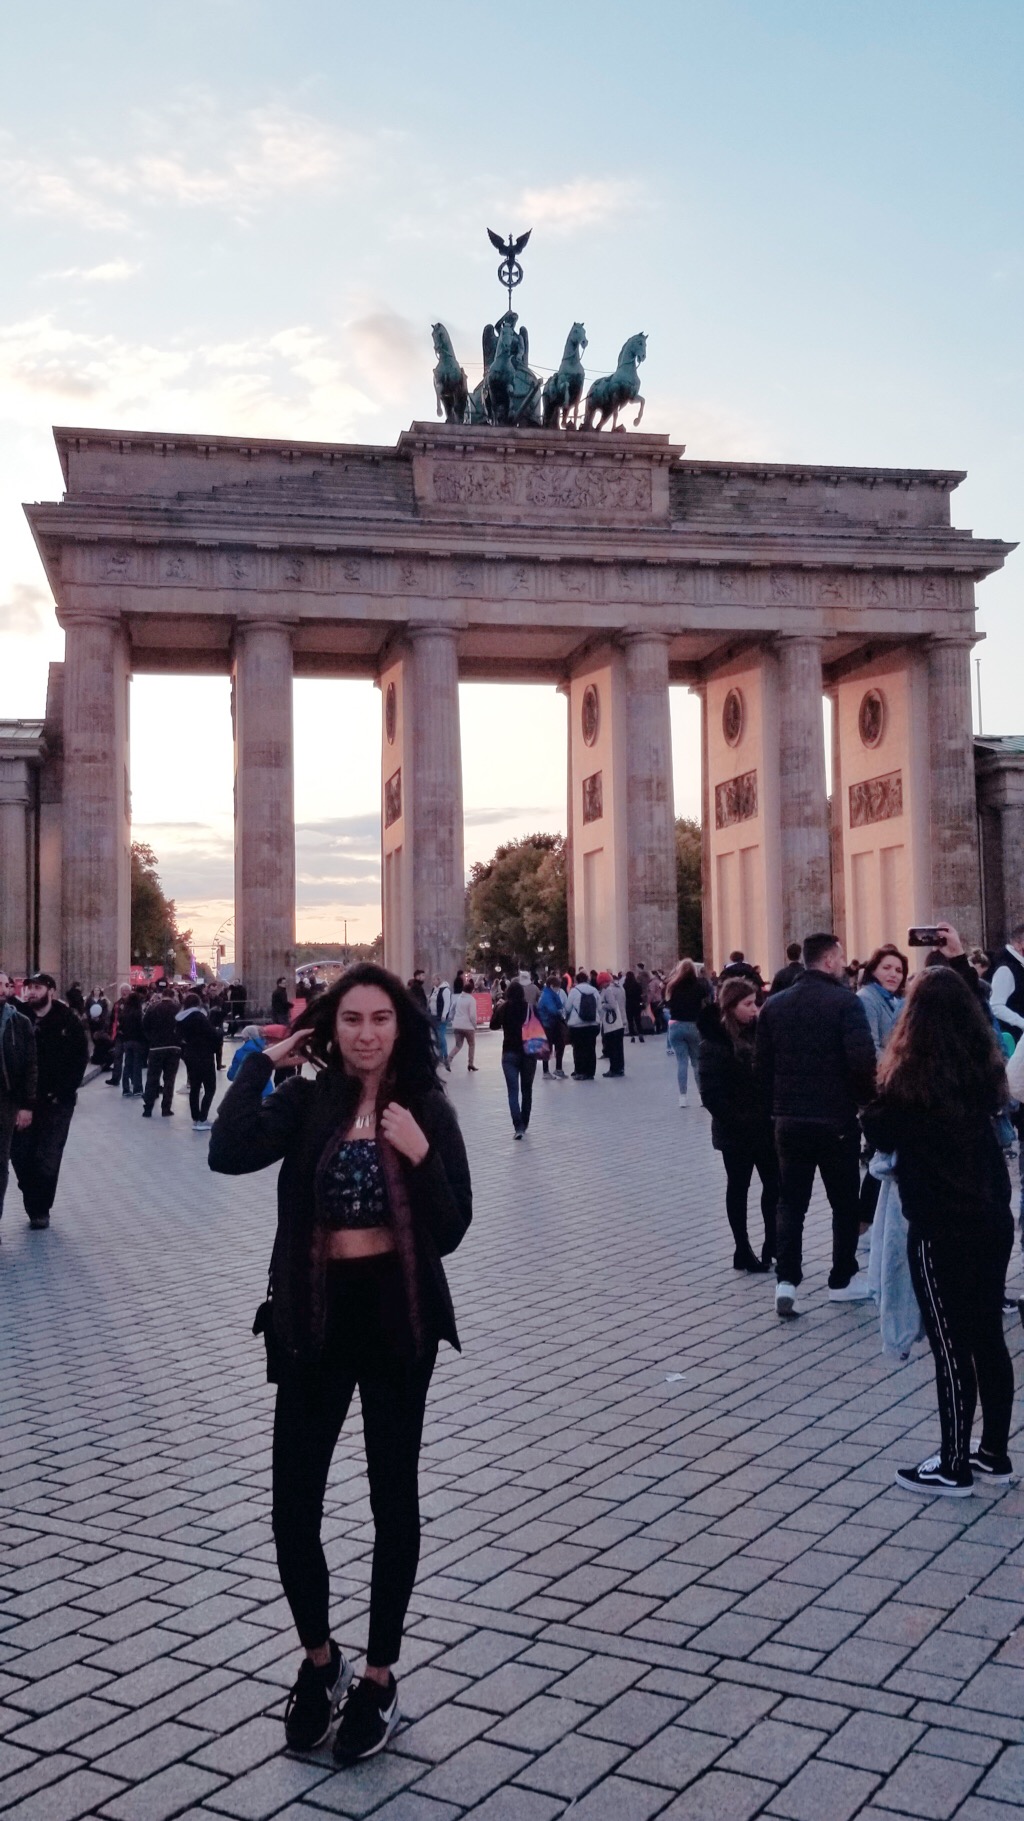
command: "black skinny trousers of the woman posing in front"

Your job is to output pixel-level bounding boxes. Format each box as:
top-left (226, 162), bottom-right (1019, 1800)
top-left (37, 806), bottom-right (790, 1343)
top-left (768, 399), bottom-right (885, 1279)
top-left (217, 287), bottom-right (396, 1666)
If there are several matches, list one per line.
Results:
top-left (273, 1253), bottom-right (437, 1668)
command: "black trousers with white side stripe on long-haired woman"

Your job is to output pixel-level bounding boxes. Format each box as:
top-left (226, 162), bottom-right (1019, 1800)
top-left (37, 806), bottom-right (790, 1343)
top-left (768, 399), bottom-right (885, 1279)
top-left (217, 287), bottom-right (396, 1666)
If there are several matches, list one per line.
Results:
top-left (907, 1215), bottom-right (1013, 1477)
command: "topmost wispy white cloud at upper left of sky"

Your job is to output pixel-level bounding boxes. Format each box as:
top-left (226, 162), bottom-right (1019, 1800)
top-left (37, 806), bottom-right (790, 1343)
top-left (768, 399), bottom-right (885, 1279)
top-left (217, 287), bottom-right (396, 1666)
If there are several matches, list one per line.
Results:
top-left (0, 93), bottom-right (386, 229)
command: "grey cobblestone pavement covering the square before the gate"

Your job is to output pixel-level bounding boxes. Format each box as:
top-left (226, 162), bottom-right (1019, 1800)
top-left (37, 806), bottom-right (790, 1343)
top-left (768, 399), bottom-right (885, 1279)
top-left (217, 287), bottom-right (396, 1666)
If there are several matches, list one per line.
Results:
top-left (0, 1038), bottom-right (1024, 1821)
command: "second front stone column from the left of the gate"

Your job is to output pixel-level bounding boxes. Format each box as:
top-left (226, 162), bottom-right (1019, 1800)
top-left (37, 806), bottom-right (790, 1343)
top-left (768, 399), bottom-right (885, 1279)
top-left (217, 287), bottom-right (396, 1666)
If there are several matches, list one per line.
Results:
top-left (231, 619), bottom-right (295, 1012)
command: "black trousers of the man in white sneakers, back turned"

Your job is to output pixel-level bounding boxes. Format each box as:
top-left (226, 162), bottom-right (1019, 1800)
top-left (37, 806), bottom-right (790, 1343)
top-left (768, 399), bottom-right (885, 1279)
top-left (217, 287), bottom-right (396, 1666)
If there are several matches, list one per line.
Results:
top-left (774, 1120), bottom-right (860, 1289)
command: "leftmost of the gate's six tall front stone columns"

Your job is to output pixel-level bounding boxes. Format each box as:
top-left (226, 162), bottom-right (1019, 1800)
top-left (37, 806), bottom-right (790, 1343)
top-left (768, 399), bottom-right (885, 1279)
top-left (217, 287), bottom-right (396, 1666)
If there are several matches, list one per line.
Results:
top-left (60, 614), bottom-right (131, 992)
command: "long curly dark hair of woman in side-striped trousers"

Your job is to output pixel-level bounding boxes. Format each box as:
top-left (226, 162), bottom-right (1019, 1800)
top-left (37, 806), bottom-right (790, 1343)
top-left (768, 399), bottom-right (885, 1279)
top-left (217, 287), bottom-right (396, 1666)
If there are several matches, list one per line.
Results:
top-left (867, 967), bottom-right (1008, 1122)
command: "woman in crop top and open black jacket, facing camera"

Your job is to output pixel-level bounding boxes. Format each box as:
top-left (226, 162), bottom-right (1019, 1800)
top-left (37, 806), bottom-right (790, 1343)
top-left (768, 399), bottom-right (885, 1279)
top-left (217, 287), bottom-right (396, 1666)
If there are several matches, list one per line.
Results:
top-left (210, 965), bottom-right (472, 1765)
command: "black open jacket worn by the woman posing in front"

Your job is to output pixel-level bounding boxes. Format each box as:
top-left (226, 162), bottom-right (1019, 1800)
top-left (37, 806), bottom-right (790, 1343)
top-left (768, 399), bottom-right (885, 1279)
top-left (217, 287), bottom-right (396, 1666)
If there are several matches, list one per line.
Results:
top-left (210, 1054), bottom-right (472, 1364)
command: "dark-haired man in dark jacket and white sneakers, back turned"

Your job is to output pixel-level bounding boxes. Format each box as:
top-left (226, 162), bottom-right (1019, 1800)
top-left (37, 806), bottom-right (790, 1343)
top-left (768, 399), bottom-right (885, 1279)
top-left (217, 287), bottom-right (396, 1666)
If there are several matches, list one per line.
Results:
top-left (756, 934), bottom-right (875, 1317)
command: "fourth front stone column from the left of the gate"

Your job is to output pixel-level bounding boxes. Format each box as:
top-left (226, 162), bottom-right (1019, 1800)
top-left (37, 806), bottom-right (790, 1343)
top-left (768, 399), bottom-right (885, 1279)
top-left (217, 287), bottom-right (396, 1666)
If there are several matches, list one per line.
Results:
top-left (623, 632), bottom-right (680, 967)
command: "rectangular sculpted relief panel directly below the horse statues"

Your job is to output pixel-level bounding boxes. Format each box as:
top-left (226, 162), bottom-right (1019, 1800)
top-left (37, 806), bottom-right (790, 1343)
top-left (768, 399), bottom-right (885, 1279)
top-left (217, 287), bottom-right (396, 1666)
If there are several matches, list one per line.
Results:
top-left (430, 461), bottom-right (652, 515)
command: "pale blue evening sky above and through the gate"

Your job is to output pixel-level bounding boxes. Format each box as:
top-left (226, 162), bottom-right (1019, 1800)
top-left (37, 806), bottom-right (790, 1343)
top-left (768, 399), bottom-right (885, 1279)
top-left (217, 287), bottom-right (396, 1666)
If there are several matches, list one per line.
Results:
top-left (0, 0), bottom-right (1024, 956)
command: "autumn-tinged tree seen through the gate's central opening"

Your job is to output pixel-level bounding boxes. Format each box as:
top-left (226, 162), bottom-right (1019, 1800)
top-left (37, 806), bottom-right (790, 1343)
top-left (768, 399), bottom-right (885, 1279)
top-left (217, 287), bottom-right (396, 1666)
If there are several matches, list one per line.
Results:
top-left (466, 834), bottom-right (568, 967)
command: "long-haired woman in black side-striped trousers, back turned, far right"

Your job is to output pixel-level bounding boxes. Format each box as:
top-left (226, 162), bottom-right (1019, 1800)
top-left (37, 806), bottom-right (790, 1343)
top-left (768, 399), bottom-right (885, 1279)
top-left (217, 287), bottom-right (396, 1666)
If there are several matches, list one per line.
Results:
top-left (864, 967), bottom-right (1013, 1499)
